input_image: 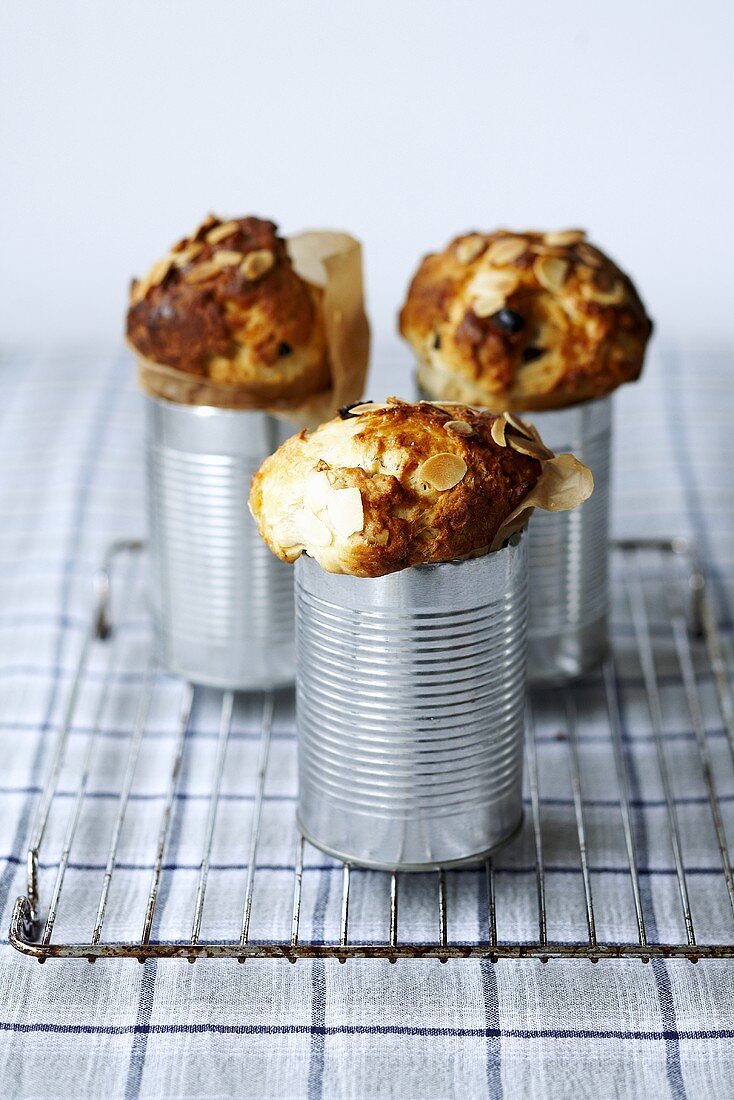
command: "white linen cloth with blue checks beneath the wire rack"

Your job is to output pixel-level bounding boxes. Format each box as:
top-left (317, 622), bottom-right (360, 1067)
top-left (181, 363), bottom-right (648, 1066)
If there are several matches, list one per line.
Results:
top-left (0, 351), bottom-right (734, 1100)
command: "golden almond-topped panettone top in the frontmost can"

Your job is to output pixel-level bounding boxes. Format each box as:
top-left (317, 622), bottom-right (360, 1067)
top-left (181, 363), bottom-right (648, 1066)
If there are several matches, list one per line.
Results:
top-left (250, 398), bottom-right (543, 576)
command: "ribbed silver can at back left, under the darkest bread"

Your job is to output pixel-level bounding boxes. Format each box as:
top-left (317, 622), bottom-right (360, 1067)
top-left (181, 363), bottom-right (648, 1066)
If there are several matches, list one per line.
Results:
top-left (145, 396), bottom-right (295, 691)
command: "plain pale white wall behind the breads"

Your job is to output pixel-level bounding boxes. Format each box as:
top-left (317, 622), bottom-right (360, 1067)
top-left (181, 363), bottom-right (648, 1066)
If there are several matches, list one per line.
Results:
top-left (0, 0), bottom-right (734, 380)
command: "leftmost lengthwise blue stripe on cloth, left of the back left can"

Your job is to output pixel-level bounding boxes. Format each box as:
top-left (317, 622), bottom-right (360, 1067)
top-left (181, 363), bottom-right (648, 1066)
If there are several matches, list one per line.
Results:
top-left (0, 355), bottom-right (119, 928)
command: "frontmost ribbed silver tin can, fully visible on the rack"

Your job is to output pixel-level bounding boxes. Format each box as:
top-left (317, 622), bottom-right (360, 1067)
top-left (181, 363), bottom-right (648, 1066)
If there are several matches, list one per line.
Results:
top-left (296, 535), bottom-right (527, 871)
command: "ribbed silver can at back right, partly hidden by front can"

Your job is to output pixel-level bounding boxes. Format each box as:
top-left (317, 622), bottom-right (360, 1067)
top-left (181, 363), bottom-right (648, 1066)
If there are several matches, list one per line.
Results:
top-left (527, 397), bottom-right (612, 683)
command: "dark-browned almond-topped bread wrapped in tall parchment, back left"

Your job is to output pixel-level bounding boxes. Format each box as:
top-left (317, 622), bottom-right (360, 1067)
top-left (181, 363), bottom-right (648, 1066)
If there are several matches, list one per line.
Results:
top-left (128, 215), bottom-right (330, 404)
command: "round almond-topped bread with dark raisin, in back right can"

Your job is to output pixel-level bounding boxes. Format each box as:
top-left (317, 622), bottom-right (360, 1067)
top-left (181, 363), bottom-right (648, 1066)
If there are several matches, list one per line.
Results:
top-left (399, 229), bottom-right (653, 411)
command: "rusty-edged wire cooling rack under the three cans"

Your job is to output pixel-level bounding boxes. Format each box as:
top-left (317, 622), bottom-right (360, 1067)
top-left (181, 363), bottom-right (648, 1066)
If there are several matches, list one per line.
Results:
top-left (10, 540), bottom-right (734, 963)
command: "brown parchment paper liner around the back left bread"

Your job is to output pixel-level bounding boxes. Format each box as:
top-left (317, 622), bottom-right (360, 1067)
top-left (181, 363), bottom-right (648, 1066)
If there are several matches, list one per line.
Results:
top-left (130, 230), bottom-right (370, 428)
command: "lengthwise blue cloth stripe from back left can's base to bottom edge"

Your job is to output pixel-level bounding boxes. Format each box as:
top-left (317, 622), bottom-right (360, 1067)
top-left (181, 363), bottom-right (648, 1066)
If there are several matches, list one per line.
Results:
top-left (124, 693), bottom-right (199, 1100)
